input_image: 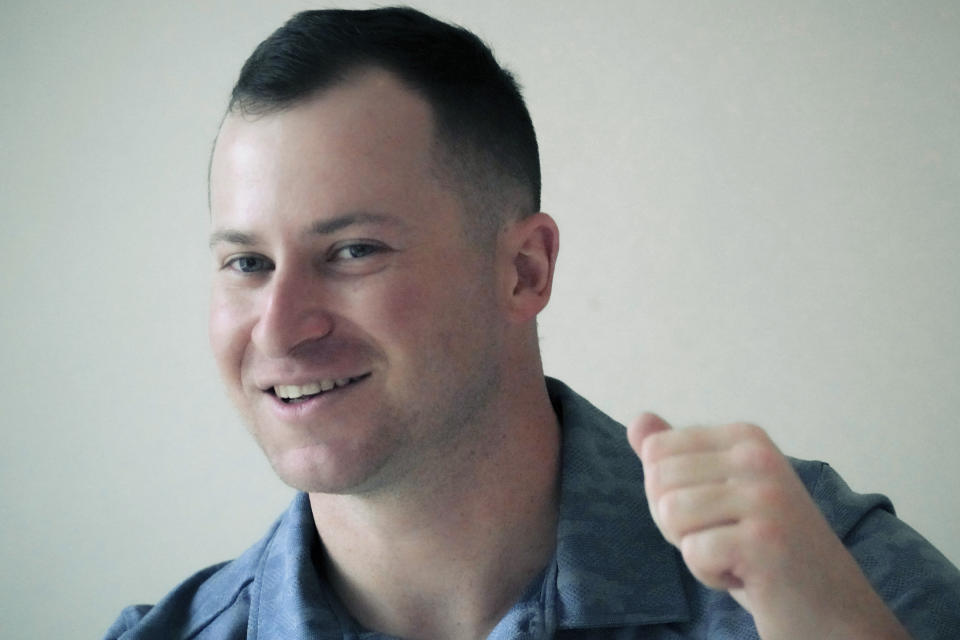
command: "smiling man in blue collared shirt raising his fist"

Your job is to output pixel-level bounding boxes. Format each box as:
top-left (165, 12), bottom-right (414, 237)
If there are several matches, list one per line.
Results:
top-left (107, 9), bottom-right (960, 639)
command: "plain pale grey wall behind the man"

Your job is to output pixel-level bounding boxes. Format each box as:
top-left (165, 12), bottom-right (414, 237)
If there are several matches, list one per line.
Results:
top-left (0, 0), bottom-right (960, 638)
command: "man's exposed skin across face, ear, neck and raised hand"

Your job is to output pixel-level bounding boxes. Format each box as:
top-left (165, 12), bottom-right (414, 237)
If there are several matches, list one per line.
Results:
top-left (210, 63), bottom-right (907, 640)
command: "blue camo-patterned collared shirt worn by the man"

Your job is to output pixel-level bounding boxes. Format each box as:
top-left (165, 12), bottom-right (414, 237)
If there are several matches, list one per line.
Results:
top-left (105, 379), bottom-right (960, 640)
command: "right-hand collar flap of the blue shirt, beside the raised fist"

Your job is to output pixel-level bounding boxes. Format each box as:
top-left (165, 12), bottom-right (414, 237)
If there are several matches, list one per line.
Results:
top-left (547, 378), bottom-right (690, 628)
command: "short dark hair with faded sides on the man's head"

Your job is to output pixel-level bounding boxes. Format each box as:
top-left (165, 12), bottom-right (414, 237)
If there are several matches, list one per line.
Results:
top-left (228, 7), bottom-right (540, 241)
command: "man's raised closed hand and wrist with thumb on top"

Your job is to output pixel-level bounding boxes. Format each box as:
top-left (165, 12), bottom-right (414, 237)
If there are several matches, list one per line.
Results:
top-left (627, 413), bottom-right (909, 640)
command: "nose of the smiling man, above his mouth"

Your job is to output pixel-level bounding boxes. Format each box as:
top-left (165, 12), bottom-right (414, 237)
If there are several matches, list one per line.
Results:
top-left (251, 270), bottom-right (333, 358)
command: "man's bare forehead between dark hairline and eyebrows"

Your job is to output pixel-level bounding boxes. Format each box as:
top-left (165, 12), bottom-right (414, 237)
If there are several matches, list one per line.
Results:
top-left (210, 69), bottom-right (450, 232)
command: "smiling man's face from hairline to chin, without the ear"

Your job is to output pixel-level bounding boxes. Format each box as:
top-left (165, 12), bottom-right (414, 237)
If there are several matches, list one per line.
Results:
top-left (210, 71), bottom-right (503, 492)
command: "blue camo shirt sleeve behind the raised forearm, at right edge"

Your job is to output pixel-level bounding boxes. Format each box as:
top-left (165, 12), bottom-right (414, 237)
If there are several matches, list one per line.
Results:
top-left (812, 463), bottom-right (960, 640)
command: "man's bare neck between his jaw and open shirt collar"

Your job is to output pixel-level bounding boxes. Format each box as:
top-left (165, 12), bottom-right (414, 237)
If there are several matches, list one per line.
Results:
top-left (310, 372), bottom-right (560, 638)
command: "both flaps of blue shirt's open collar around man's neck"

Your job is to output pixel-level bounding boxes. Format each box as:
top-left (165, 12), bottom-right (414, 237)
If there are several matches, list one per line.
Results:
top-left (248, 378), bottom-right (690, 640)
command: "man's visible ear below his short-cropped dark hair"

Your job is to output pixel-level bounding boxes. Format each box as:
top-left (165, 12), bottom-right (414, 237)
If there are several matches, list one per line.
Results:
top-left (504, 212), bottom-right (560, 324)
